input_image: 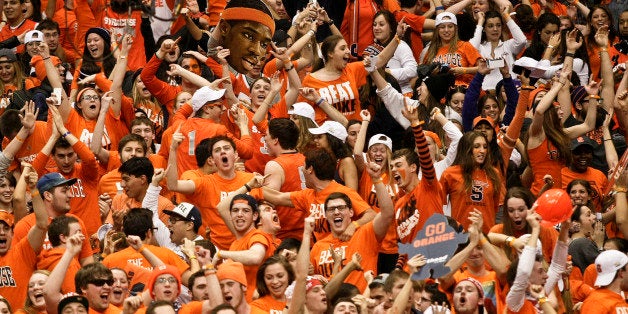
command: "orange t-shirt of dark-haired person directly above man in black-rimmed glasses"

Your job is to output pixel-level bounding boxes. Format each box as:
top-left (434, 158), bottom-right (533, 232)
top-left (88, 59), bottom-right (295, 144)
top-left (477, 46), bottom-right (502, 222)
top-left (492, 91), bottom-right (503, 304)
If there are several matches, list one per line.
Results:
top-left (290, 181), bottom-right (372, 242)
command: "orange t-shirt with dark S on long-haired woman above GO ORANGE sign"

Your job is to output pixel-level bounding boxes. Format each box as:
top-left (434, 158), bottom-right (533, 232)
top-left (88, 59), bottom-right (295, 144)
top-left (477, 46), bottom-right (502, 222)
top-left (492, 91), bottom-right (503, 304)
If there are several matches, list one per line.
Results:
top-left (440, 165), bottom-right (505, 233)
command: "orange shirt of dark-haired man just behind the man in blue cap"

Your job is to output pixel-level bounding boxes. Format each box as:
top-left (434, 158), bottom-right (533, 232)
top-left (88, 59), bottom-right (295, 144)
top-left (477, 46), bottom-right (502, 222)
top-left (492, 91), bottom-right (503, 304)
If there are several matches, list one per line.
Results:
top-left (33, 139), bottom-right (100, 237)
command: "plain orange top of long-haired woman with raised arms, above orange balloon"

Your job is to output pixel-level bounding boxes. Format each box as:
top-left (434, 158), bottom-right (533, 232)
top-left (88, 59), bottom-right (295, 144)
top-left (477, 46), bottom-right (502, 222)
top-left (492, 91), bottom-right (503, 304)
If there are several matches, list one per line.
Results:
top-left (527, 138), bottom-right (565, 195)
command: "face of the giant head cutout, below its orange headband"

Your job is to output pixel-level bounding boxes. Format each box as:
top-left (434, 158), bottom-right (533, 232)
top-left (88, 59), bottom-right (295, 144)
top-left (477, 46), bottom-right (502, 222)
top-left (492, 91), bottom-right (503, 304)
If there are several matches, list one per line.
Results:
top-left (220, 21), bottom-right (272, 74)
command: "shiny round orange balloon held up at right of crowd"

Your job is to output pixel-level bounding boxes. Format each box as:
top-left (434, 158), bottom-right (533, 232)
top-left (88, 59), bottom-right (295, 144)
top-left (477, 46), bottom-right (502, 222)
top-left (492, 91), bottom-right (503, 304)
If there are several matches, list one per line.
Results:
top-left (536, 189), bottom-right (573, 225)
